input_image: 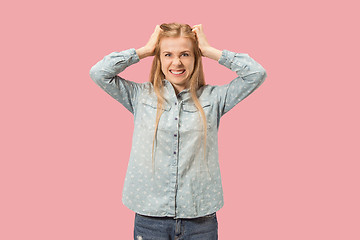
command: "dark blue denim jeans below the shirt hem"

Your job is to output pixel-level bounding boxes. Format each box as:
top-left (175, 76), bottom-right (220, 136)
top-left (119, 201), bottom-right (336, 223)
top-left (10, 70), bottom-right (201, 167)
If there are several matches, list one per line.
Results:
top-left (134, 213), bottom-right (218, 240)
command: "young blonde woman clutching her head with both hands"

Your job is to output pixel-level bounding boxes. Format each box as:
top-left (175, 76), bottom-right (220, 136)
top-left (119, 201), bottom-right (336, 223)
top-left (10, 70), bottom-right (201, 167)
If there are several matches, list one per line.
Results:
top-left (90, 23), bottom-right (266, 240)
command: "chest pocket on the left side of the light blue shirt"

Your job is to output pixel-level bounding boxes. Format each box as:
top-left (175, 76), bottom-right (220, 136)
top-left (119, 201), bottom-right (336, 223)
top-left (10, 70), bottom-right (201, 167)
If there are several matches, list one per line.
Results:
top-left (139, 98), bottom-right (171, 131)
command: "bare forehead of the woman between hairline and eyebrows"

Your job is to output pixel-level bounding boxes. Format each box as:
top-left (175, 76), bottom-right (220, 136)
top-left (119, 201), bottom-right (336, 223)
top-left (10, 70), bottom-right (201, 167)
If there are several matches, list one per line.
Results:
top-left (160, 37), bottom-right (193, 52)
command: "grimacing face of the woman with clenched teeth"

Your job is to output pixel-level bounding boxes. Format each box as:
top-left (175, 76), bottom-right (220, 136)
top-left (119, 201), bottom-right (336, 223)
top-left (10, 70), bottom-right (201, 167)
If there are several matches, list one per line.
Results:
top-left (160, 37), bottom-right (195, 93)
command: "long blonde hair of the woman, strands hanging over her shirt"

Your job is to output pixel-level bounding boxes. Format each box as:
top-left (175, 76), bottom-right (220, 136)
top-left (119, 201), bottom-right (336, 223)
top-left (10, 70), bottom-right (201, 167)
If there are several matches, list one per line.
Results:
top-left (150, 23), bottom-right (207, 169)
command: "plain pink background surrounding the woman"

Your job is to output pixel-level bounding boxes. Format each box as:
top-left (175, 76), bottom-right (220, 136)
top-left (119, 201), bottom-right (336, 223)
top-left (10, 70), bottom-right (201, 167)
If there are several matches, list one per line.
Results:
top-left (0, 0), bottom-right (360, 240)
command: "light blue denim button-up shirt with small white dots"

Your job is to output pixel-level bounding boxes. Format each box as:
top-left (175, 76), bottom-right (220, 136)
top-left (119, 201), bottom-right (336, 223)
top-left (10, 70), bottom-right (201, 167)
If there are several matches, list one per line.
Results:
top-left (90, 48), bottom-right (266, 218)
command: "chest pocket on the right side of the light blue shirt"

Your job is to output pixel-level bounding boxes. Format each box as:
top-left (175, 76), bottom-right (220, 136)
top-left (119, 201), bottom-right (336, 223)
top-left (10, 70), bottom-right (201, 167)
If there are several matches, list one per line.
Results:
top-left (180, 101), bottom-right (212, 131)
